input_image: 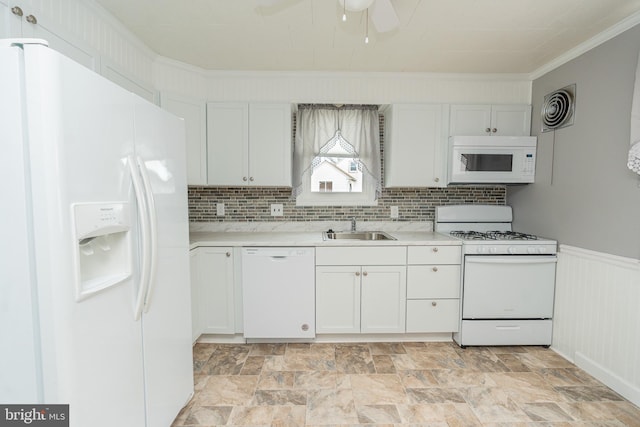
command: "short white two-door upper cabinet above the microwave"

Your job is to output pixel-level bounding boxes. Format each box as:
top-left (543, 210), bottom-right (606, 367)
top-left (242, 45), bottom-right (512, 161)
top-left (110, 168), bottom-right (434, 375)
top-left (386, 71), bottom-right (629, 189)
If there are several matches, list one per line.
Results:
top-left (449, 104), bottom-right (531, 136)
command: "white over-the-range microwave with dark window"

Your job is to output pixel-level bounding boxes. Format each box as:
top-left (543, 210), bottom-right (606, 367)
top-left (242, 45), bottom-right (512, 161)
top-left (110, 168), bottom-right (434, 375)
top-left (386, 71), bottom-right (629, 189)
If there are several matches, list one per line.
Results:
top-left (448, 136), bottom-right (537, 184)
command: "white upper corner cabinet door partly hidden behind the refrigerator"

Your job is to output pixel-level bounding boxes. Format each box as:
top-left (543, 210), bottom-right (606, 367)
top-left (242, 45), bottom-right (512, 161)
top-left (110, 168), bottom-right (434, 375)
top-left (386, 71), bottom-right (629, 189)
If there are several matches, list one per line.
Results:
top-left (160, 93), bottom-right (207, 185)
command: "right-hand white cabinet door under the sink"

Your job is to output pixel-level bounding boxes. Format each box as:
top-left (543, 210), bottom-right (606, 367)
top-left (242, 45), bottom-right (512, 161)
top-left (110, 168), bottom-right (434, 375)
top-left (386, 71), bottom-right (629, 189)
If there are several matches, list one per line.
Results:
top-left (360, 267), bottom-right (407, 333)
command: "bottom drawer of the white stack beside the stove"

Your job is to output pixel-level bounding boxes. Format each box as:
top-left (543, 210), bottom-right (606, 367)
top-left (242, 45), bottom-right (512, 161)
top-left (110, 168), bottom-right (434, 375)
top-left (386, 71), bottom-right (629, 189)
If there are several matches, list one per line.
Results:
top-left (407, 299), bottom-right (460, 332)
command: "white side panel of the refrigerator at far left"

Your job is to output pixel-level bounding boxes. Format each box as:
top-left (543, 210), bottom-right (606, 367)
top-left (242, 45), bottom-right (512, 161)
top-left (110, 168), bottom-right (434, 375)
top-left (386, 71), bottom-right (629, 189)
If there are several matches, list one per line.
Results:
top-left (0, 43), bottom-right (40, 403)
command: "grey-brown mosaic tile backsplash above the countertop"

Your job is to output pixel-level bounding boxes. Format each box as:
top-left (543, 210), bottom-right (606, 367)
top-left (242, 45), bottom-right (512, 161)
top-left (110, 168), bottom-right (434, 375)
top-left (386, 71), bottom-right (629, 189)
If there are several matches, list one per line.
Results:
top-left (189, 186), bottom-right (506, 222)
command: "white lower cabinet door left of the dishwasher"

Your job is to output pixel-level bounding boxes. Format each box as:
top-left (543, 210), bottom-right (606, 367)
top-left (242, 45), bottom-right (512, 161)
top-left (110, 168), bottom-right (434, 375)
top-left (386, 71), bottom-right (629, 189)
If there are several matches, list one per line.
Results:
top-left (198, 247), bottom-right (235, 334)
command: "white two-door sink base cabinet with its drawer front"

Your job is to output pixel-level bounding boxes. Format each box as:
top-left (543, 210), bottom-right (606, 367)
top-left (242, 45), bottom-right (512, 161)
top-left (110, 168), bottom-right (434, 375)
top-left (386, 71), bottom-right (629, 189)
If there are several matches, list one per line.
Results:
top-left (316, 247), bottom-right (406, 334)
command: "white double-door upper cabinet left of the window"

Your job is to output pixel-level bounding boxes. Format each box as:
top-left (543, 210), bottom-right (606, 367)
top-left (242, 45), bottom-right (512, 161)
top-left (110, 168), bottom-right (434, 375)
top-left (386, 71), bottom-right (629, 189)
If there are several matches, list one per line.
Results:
top-left (207, 102), bottom-right (292, 187)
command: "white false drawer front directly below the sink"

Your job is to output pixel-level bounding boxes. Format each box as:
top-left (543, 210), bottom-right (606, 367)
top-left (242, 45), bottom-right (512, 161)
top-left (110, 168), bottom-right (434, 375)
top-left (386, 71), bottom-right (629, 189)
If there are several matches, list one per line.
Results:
top-left (316, 246), bottom-right (407, 265)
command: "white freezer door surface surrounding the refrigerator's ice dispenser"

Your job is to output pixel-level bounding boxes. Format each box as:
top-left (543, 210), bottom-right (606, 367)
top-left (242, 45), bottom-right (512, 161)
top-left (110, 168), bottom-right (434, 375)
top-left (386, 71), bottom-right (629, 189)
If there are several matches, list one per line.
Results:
top-left (17, 41), bottom-right (145, 427)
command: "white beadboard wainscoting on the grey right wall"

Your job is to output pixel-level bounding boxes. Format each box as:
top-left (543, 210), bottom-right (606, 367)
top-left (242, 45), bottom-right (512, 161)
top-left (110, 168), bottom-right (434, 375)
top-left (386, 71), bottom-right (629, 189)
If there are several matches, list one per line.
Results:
top-left (552, 245), bottom-right (640, 406)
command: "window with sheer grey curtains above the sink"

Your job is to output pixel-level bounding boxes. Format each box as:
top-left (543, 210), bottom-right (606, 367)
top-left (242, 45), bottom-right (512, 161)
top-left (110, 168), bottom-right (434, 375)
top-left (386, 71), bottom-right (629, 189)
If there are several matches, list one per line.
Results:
top-left (293, 106), bottom-right (380, 206)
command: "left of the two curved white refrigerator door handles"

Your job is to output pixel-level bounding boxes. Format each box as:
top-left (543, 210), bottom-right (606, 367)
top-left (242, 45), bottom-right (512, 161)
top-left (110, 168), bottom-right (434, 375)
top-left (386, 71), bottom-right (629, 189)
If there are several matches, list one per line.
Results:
top-left (127, 155), bottom-right (151, 320)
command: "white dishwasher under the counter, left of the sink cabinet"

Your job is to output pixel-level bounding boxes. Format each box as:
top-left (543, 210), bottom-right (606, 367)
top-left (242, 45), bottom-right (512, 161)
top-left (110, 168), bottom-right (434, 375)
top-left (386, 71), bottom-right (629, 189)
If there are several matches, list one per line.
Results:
top-left (242, 247), bottom-right (316, 339)
